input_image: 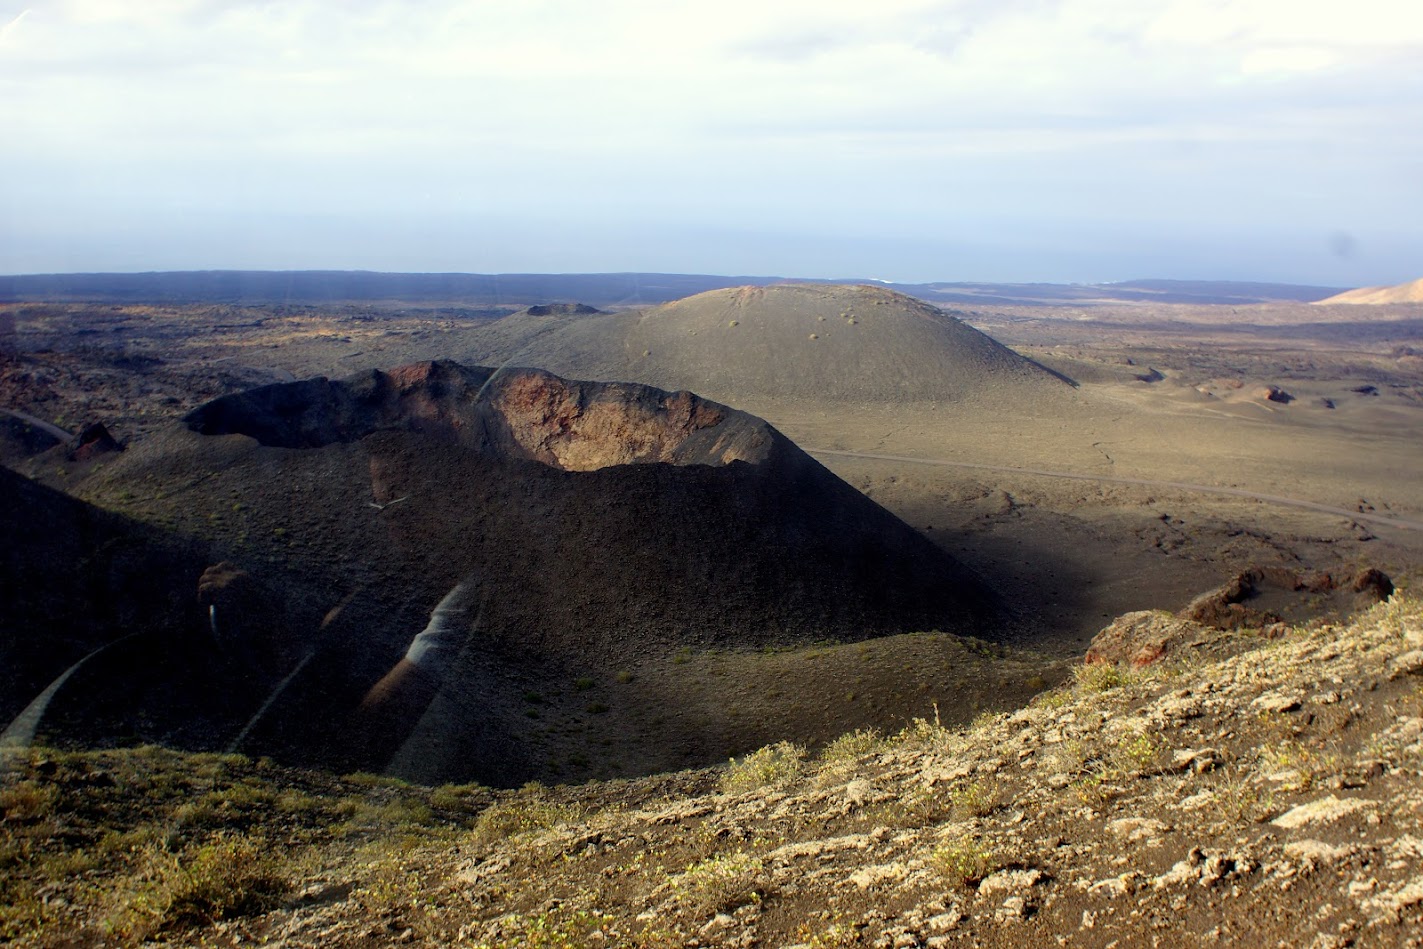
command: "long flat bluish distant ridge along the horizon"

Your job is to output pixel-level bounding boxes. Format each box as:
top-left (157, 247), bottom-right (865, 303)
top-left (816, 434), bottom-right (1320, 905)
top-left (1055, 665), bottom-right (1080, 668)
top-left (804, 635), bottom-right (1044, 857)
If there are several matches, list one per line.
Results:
top-left (0, 270), bottom-right (1342, 309)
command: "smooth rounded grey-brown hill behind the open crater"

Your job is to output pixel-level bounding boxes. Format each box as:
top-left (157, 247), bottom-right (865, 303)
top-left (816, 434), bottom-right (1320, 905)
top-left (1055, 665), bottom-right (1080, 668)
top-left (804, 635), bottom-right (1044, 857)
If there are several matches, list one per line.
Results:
top-left (461, 283), bottom-right (1069, 404)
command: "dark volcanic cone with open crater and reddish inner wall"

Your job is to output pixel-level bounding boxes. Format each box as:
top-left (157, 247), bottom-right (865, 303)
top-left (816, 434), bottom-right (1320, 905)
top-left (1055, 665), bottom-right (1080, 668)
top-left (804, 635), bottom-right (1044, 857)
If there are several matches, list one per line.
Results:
top-left (64, 361), bottom-right (1003, 783)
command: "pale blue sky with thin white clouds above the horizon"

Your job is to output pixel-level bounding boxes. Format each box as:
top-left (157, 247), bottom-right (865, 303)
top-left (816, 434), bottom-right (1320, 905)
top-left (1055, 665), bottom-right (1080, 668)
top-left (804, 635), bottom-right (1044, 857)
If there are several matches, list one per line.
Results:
top-left (0, 0), bottom-right (1423, 286)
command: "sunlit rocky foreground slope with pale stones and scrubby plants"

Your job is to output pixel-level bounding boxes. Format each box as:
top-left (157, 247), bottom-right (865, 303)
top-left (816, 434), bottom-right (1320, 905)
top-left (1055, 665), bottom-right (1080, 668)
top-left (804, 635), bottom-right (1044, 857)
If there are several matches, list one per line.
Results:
top-left (0, 593), bottom-right (1423, 948)
